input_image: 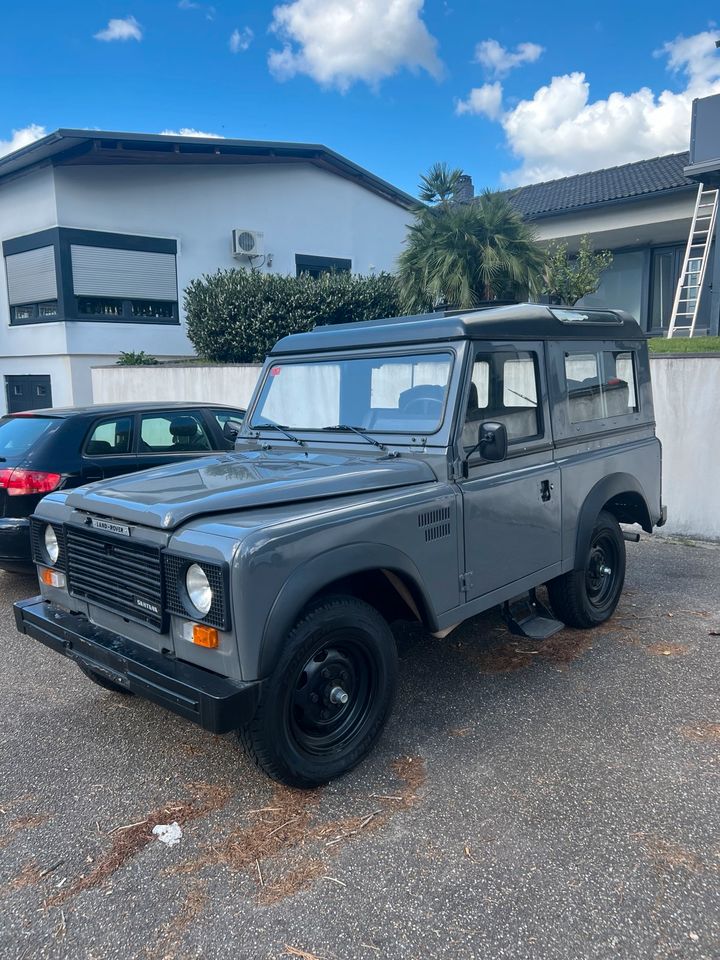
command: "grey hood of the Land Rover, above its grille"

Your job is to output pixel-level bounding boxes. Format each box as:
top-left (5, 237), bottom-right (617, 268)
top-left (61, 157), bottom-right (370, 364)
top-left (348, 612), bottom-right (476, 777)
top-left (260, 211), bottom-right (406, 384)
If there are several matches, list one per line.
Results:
top-left (66, 451), bottom-right (436, 530)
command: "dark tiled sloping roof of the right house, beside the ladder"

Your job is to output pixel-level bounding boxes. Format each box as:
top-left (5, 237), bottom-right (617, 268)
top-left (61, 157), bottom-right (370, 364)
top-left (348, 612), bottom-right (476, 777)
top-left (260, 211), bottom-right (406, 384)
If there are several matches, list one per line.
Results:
top-left (508, 151), bottom-right (697, 220)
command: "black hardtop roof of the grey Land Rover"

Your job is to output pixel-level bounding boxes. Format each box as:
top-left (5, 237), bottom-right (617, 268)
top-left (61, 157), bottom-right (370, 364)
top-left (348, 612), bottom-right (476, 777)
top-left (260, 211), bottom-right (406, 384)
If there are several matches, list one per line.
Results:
top-left (271, 303), bottom-right (647, 356)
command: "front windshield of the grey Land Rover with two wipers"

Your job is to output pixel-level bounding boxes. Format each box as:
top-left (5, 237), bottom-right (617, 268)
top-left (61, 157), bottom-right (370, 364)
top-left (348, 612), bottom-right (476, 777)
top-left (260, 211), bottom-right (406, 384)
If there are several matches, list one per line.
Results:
top-left (250, 353), bottom-right (452, 434)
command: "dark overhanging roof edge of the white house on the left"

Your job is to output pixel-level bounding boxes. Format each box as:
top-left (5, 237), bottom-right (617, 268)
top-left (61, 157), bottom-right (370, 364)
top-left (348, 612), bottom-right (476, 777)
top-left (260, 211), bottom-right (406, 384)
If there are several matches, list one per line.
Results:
top-left (0, 129), bottom-right (417, 210)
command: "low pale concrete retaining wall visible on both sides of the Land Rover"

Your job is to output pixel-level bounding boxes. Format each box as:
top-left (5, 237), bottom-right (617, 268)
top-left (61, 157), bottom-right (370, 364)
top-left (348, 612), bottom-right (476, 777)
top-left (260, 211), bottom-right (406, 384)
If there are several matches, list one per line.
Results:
top-left (92, 356), bottom-right (720, 539)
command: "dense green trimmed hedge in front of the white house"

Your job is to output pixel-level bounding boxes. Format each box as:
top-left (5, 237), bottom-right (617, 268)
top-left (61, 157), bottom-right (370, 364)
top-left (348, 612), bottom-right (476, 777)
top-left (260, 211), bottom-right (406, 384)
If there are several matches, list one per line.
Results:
top-left (184, 269), bottom-right (400, 363)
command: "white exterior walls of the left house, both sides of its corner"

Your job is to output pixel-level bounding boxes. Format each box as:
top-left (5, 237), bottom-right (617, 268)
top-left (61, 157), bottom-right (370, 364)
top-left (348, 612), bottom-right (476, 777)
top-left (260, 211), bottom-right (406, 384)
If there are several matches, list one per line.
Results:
top-left (0, 163), bottom-right (411, 415)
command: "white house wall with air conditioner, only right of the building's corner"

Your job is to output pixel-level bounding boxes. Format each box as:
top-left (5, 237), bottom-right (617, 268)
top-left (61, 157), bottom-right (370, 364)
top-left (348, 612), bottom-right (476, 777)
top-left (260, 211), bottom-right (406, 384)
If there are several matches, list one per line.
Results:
top-left (55, 163), bottom-right (411, 356)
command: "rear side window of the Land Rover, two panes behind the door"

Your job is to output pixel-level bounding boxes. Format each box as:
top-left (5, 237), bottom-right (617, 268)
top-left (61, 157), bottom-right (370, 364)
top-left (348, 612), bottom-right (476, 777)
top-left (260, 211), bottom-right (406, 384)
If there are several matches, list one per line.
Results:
top-left (565, 350), bottom-right (638, 423)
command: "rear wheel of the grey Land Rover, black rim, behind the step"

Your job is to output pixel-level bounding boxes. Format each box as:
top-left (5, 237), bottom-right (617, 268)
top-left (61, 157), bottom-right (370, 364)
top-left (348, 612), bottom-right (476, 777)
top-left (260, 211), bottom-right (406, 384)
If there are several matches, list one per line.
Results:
top-left (547, 510), bottom-right (625, 629)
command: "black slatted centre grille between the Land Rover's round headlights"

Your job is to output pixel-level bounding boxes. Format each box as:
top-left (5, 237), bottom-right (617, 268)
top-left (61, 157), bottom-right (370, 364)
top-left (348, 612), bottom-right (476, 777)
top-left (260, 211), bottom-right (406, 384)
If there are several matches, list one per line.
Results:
top-left (65, 526), bottom-right (164, 632)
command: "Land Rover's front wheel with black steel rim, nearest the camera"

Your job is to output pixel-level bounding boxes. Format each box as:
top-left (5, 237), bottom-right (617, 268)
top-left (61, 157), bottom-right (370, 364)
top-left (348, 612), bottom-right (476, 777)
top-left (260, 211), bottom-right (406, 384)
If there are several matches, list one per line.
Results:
top-left (238, 596), bottom-right (397, 788)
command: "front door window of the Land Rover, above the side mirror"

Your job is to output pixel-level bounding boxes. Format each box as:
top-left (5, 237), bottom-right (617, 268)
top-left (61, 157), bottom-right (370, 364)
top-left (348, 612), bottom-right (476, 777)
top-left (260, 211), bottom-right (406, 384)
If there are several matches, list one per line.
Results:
top-left (463, 350), bottom-right (541, 447)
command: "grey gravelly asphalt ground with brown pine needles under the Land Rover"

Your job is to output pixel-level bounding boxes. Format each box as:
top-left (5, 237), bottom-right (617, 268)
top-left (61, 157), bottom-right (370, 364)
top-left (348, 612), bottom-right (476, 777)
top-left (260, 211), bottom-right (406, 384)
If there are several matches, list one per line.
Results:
top-left (0, 540), bottom-right (720, 960)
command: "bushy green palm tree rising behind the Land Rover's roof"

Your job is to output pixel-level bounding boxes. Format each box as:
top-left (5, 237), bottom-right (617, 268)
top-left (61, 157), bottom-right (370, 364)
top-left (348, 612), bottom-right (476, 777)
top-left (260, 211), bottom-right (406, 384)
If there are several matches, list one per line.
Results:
top-left (398, 164), bottom-right (545, 312)
